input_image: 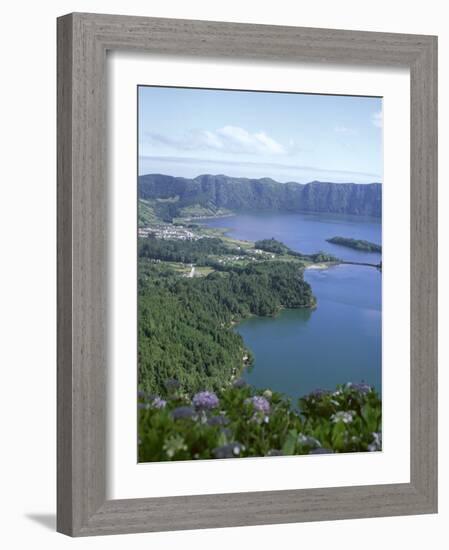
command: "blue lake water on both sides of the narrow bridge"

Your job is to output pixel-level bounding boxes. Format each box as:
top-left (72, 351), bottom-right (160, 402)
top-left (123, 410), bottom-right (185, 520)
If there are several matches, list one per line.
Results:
top-left (203, 214), bottom-right (382, 399)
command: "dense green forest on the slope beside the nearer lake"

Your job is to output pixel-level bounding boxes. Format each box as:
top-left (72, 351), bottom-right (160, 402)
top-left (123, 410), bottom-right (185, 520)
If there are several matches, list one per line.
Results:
top-left (138, 258), bottom-right (315, 393)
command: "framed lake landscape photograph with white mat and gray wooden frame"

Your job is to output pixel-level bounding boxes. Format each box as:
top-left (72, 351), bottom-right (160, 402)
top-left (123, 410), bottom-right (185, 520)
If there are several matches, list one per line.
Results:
top-left (57, 14), bottom-right (437, 536)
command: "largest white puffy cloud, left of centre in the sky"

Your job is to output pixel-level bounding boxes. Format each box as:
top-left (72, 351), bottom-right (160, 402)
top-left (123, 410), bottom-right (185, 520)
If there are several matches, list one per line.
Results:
top-left (145, 126), bottom-right (290, 155)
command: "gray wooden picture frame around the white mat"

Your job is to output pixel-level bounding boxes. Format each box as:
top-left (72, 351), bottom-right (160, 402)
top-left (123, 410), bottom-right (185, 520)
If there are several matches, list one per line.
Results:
top-left (57, 13), bottom-right (437, 536)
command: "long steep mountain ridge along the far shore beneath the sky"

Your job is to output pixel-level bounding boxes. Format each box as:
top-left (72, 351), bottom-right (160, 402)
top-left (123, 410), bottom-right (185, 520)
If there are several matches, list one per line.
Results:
top-left (139, 174), bottom-right (382, 221)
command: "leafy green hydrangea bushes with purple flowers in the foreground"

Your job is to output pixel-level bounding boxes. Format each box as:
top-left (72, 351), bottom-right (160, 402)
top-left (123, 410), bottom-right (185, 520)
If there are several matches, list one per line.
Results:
top-left (138, 381), bottom-right (382, 462)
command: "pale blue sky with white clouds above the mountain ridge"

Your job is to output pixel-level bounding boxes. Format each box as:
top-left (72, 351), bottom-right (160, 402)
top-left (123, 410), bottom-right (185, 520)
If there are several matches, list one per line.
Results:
top-left (138, 86), bottom-right (383, 183)
